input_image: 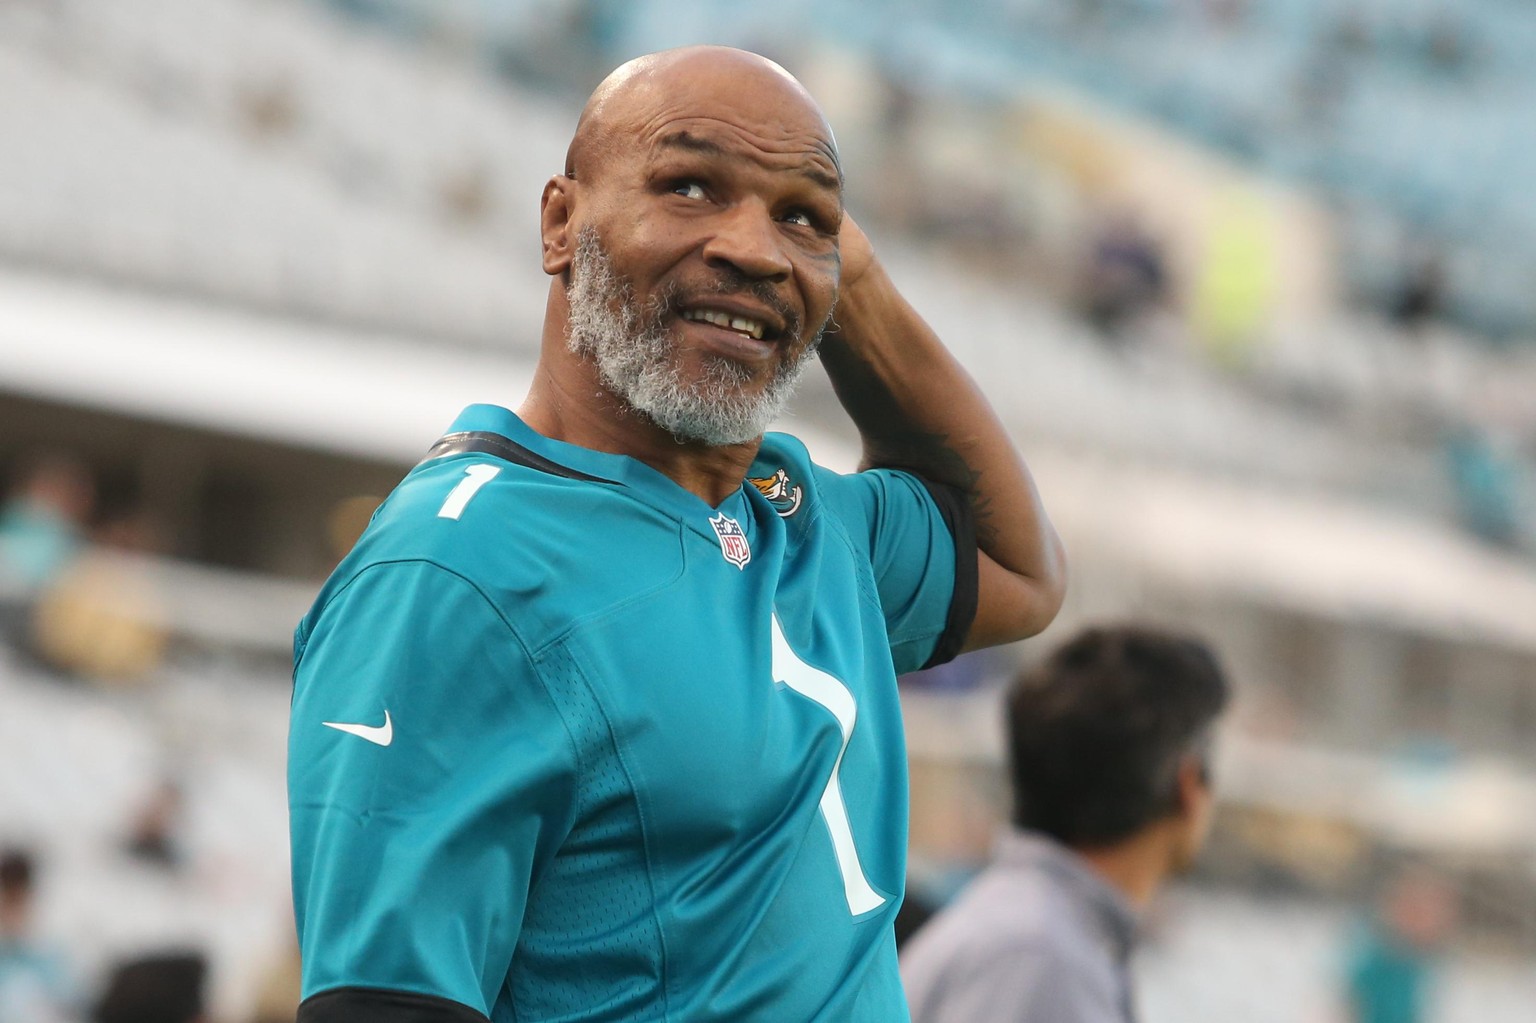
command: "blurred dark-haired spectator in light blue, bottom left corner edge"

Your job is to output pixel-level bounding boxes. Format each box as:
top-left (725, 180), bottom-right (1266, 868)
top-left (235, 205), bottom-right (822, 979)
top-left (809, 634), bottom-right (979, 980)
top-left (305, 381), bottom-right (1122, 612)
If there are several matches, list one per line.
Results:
top-left (0, 849), bottom-right (78, 1023)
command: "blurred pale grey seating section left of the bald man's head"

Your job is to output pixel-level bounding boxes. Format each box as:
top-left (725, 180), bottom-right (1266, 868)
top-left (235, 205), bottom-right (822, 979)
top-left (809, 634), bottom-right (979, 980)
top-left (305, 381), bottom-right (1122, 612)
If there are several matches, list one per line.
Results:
top-left (0, 0), bottom-right (559, 346)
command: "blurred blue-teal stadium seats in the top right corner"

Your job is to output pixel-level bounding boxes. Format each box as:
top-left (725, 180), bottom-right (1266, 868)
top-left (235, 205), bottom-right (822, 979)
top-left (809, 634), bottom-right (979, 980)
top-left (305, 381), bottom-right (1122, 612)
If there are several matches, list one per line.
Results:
top-left (897, 0), bottom-right (1536, 329)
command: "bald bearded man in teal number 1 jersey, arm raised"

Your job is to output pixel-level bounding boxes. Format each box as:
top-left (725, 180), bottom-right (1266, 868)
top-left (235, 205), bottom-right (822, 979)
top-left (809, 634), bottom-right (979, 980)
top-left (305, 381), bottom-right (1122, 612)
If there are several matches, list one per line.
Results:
top-left (289, 48), bottom-right (1063, 1023)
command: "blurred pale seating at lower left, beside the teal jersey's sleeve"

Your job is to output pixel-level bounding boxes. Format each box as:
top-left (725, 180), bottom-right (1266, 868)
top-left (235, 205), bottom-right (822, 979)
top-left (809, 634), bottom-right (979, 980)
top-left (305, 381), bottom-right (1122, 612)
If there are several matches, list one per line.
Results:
top-left (0, 647), bottom-right (292, 1020)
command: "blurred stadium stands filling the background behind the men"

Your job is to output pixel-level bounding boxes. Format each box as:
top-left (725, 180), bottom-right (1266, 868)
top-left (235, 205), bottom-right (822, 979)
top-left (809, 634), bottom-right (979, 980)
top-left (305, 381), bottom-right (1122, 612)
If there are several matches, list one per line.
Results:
top-left (0, 0), bottom-right (1536, 1023)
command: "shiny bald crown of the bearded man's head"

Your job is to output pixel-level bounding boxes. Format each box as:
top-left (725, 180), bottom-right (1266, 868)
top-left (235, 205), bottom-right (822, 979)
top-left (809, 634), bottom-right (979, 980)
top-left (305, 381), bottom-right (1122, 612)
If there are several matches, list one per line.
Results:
top-left (565, 46), bottom-right (842, 178)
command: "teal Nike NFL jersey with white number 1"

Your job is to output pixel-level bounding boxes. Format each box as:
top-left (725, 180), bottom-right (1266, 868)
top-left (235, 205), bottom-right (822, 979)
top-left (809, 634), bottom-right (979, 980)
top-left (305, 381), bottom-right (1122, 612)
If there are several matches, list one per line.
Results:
top-left (289, 406), bottom-right (975, 1023)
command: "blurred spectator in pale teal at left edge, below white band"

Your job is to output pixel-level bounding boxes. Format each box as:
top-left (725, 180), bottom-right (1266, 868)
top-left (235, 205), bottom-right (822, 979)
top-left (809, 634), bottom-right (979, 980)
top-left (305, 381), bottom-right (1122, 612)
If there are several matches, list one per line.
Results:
top-left (0, 455), bottom-right (95, 593)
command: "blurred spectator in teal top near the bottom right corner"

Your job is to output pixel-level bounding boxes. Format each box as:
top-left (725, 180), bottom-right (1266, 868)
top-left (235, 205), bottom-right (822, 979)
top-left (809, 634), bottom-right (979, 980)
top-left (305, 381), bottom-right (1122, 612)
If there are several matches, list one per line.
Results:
top-left (1344, 869), bottom-right (1456, 1023)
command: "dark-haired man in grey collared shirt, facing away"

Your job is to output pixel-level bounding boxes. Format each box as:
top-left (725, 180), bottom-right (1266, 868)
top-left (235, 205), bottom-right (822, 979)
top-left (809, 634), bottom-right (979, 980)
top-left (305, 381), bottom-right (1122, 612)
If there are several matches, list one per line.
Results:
top-left (902, 627), bottom-right (1227, 1023)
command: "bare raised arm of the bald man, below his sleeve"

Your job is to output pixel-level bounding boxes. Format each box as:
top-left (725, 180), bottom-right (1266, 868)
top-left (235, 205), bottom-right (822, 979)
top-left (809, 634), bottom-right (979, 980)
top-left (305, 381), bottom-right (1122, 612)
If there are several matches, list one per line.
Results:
top-left (822, 263), bottom-right (1066, 647)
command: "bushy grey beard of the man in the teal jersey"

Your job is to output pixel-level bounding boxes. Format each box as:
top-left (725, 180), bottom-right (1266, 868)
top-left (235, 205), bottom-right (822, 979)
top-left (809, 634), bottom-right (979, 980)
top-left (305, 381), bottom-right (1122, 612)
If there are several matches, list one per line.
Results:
top-left (565, 227), bottom-right (825, 445)
